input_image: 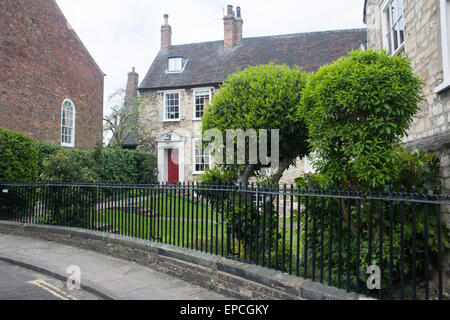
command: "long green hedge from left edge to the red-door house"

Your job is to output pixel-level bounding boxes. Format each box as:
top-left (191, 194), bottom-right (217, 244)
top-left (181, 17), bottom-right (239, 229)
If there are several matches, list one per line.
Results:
top-left (0, 129), bottom-right (157, 184)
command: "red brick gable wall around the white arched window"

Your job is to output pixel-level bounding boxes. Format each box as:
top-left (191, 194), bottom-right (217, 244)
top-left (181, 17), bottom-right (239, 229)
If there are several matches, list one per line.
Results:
top-left (0, 0), bottom-right (104, 149)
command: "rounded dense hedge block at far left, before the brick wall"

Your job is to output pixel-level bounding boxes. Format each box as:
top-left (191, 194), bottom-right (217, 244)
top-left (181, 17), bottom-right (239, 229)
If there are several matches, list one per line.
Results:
top-left (0, 128), bottom-right (38, 182)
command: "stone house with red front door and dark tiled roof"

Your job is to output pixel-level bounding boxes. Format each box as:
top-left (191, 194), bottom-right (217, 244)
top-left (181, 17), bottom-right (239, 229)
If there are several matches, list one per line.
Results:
top-left (127, 6), bottom-right (366, 183)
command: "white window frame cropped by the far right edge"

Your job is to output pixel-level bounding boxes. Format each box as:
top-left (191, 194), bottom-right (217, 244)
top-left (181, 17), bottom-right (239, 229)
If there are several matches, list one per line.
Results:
top-left (434, 0), bottom-right (450, 93)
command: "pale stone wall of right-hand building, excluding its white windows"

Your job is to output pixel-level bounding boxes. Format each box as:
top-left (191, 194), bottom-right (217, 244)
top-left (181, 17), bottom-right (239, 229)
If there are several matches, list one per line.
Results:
top-left (365, 0), bottom-right (450, 198)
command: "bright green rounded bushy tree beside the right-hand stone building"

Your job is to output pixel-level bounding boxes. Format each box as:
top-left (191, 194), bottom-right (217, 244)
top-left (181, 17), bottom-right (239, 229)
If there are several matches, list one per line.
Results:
top-left (300, 50), bottom-right (422, 187)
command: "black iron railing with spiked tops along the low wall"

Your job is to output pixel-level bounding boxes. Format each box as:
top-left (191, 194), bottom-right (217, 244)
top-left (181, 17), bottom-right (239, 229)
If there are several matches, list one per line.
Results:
top-left (0, 183), bottom-right (450, 299)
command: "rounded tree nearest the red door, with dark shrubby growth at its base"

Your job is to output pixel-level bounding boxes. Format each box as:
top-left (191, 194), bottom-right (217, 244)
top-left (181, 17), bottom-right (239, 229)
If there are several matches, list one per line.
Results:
top-left (200, 64), bottom-right (308, 259)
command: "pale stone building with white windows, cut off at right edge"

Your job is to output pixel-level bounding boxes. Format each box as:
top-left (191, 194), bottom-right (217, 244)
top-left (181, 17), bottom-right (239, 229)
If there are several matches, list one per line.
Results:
top-left (364, 0), bottom-right (450, 198)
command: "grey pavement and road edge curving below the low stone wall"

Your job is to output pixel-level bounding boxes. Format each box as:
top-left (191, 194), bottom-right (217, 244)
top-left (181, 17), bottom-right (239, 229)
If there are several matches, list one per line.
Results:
top-left (0, 234), bottom-right (228, 300)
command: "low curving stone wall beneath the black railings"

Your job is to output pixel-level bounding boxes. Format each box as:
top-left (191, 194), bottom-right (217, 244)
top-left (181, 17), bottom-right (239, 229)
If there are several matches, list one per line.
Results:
top-left (0, 221), bottom-right (364, 300)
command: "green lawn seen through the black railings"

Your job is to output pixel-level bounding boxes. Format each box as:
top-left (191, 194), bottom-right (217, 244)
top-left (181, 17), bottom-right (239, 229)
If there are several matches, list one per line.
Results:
top-left (91, 192), bottom-right (298, 262)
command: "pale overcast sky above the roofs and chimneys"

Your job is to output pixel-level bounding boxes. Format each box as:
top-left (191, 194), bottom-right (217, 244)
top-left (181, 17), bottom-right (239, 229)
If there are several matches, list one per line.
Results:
top-left (56, 0), bottom-right (365, 112)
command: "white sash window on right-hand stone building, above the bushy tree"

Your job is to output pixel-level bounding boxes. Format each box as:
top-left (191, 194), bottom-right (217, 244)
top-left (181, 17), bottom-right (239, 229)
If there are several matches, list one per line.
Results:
top-left (381, 0), bottom-right (406, 56)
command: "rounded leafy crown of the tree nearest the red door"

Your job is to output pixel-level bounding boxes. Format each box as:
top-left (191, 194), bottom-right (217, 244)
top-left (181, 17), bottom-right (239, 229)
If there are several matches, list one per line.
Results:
top-left (202, 63), bottom-right (308, 184)
